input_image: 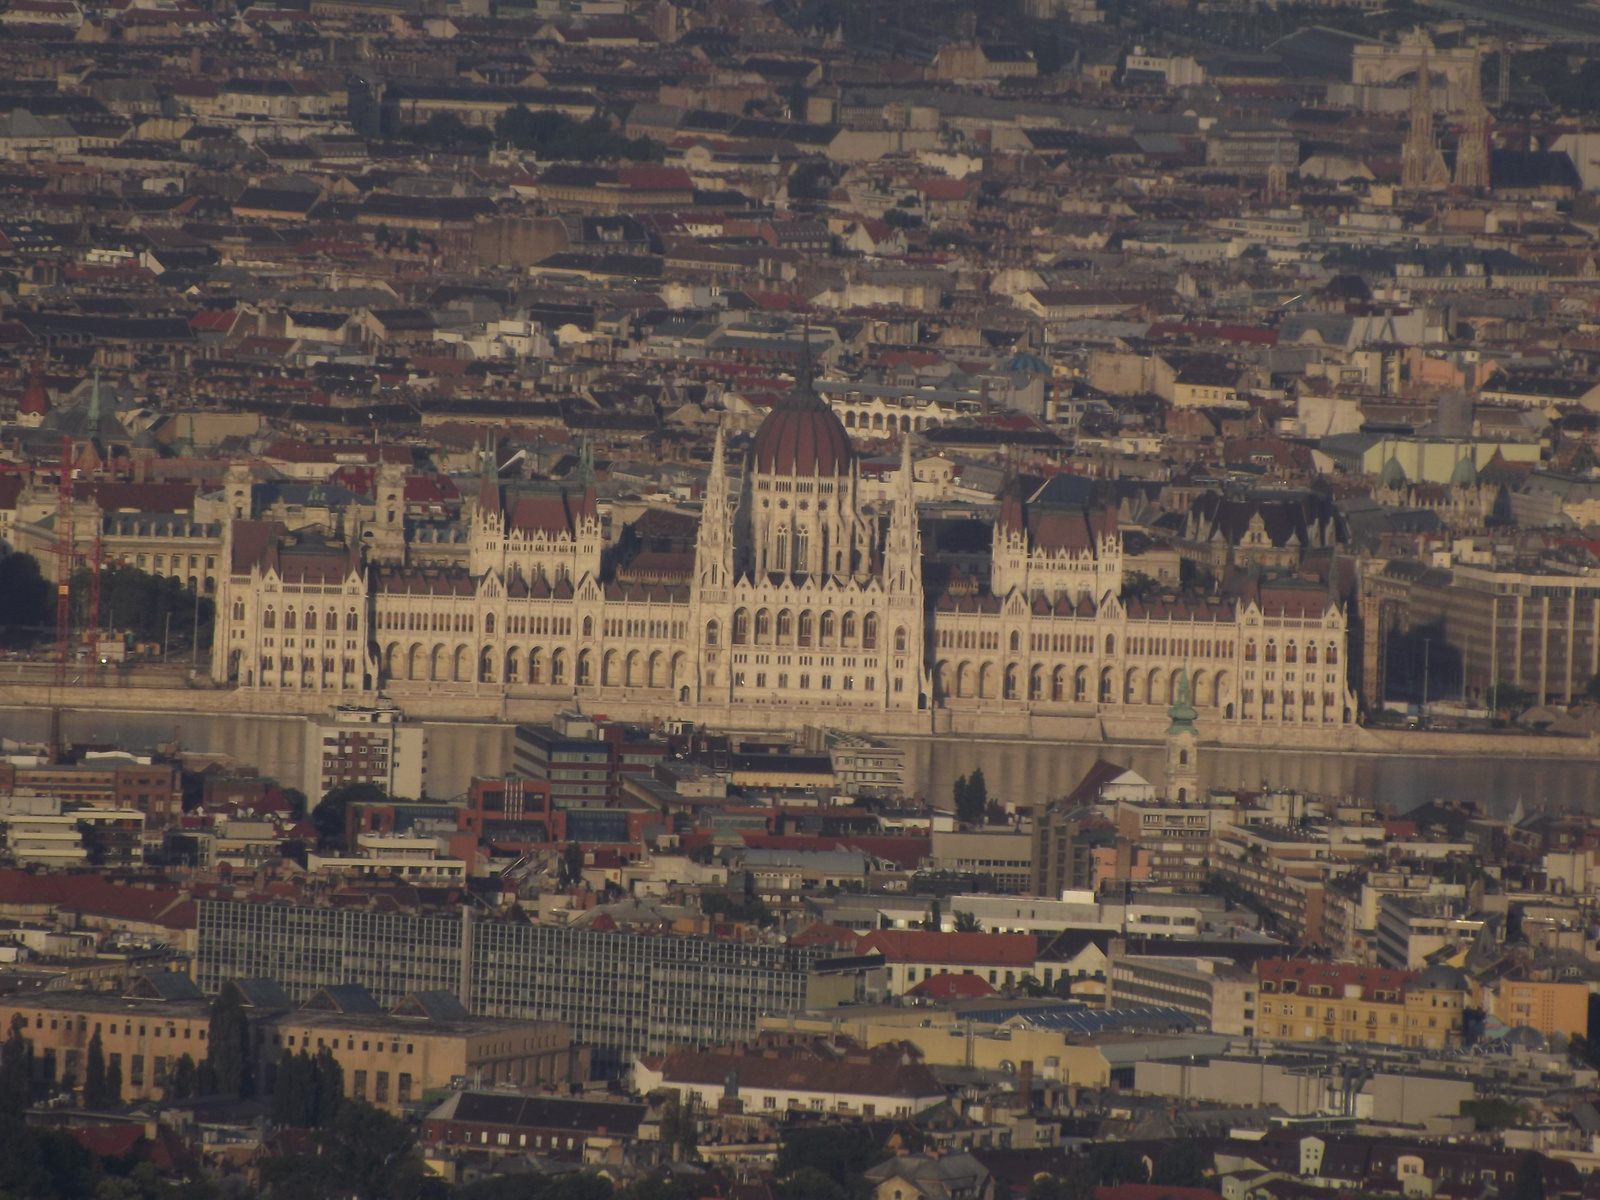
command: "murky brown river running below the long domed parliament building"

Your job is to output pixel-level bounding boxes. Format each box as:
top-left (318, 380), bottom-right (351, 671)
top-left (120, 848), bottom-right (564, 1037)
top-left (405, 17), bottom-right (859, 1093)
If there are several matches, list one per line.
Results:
top-left (0, 709), bottom-right (1600, 816)
